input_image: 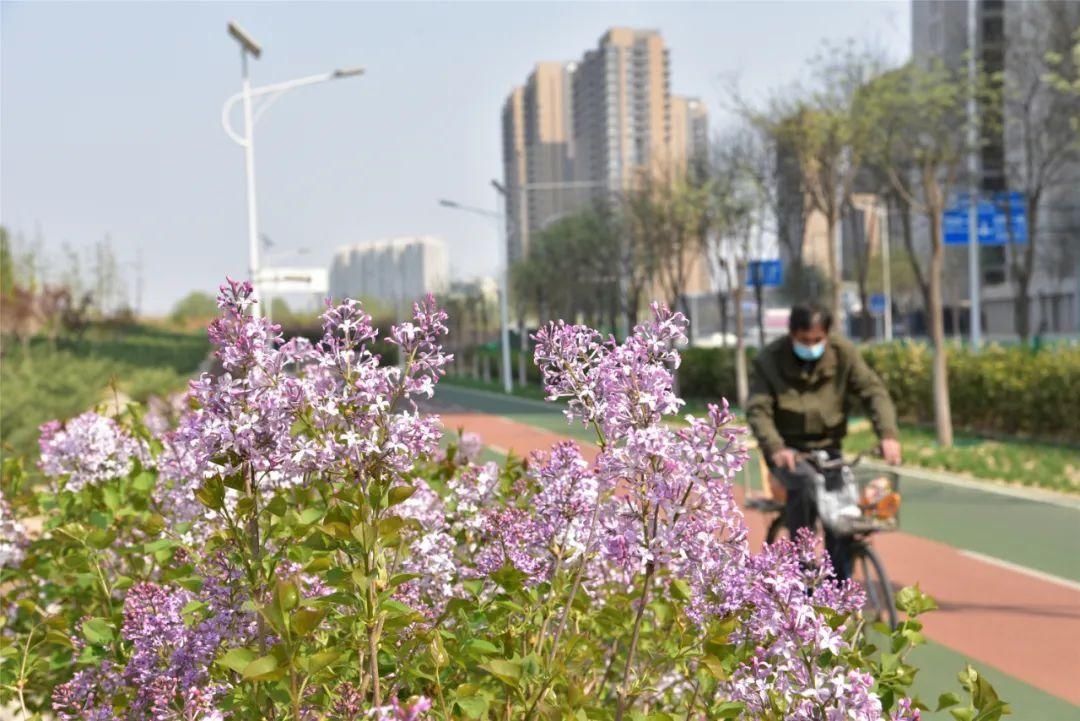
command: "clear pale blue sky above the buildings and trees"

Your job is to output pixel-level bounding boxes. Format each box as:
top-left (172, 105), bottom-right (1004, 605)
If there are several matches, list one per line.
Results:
top-left (0, 1), bottom-right (910, 313)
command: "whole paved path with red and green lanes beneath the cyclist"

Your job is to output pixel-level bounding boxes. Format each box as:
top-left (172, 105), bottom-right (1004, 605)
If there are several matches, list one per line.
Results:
top-left (429, 385), bottom-right (1080, 721)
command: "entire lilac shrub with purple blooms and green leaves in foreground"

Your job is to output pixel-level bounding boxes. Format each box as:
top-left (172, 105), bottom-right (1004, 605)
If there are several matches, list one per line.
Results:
top-left (0, 282), bottom-right (1007, 721)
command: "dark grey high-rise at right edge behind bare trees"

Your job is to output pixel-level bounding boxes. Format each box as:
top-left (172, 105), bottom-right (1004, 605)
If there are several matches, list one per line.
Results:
top-left (912, 0), bottom-right (1080, 335)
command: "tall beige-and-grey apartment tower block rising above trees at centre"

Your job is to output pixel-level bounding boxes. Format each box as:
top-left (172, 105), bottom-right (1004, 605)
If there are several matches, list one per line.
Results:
top-left (502, 28), bottom-right (708, 261)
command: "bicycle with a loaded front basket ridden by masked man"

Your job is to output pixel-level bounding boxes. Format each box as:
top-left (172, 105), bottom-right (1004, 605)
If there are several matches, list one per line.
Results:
top-left (746, 453), bottom-right (900, 628)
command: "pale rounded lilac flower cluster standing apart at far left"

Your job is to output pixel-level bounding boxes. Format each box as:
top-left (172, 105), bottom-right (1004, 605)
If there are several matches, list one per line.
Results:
top-left (38, 411), bottom-right (147, 491)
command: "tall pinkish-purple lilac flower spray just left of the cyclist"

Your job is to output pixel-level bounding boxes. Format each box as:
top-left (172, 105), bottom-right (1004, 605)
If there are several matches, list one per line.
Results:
top-left (536, 305), bottom-right (746, 583)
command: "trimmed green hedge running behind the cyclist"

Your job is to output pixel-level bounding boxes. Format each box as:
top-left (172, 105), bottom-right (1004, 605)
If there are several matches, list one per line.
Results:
top-left (679, 341), bottom-right (1080, 443)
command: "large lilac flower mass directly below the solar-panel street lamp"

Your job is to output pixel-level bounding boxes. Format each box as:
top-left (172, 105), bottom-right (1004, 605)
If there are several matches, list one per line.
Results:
top-left (159, 280), bottom-right (450, 528)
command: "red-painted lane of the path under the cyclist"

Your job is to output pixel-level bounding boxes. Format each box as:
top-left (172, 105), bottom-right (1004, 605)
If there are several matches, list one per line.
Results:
top-left (441, 409), bottom-right (1080, 706)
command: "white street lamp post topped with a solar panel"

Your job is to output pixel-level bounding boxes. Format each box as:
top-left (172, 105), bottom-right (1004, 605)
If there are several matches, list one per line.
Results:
top-left (221, 23), bottom-right (364, 316)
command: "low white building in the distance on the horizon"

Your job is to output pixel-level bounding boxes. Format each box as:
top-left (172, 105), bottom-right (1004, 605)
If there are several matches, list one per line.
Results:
top-left (329, 235), bottom-right (449, 308)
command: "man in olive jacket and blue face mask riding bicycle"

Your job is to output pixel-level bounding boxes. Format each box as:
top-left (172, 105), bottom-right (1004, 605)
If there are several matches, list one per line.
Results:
top-left (746, 303), bottom-right (901, 580)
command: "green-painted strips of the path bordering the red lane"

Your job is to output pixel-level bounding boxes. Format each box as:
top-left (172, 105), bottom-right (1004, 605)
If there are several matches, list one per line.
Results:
top-left (435, 383), bottom-right (1080, 721)
